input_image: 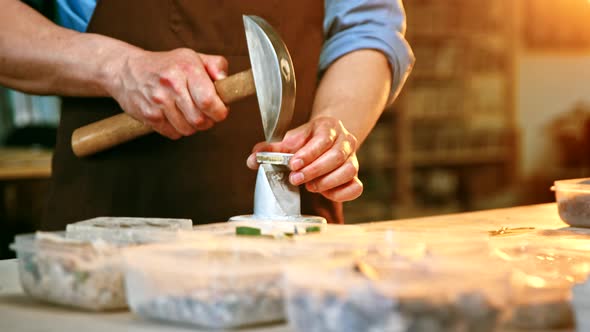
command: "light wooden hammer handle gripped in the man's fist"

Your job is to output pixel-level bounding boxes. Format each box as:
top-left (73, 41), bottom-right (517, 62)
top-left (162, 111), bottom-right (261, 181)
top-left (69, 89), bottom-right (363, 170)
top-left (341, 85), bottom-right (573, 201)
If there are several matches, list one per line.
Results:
top-left (72, 69), bottom-right (256, 157)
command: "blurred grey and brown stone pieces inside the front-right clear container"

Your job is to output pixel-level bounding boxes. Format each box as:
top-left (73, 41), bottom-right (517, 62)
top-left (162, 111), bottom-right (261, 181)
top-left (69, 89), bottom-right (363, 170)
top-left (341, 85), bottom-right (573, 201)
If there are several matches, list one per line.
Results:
top-left (287, 286), bottom-right (500, 332)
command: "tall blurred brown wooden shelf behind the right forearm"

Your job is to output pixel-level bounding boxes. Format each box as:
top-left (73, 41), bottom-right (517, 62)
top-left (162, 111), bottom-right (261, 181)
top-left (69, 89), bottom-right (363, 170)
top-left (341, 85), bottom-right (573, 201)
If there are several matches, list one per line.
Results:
top-left (346, 0), bottom-right (518, 222)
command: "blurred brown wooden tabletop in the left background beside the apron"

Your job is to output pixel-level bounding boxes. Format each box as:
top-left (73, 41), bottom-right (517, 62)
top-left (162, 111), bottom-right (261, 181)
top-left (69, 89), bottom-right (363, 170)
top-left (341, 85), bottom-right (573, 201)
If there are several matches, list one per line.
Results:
top-left (0, 149), bottom-right (52, 181)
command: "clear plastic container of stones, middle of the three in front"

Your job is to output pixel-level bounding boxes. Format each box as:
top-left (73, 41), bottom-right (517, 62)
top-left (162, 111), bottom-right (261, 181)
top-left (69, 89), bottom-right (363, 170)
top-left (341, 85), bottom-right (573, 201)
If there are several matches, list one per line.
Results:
top-left (125, 238), bottom-right (346, 328)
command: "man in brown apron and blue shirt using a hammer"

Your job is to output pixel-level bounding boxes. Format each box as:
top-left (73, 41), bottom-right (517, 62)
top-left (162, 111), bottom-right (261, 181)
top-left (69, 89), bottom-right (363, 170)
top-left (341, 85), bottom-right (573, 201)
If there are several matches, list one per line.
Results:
top-left (0, 0), bottom-right (413, 229)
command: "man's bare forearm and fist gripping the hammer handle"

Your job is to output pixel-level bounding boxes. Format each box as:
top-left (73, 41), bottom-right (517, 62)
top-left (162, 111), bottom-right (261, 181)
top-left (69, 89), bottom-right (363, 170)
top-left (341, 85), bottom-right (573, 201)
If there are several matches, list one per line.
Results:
top-left (0, 0), bottom-right (228, 139)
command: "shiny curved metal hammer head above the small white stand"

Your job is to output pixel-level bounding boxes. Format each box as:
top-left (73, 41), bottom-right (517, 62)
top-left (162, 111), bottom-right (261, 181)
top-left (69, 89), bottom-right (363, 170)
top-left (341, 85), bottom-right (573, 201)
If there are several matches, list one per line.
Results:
top-left (244, 16), bottom-right (295, 142)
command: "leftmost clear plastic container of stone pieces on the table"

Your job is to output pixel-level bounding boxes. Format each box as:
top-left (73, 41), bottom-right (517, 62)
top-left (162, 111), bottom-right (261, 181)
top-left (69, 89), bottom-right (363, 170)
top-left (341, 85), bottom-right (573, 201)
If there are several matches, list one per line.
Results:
top-left (11, 233), bottom-right (127, 311)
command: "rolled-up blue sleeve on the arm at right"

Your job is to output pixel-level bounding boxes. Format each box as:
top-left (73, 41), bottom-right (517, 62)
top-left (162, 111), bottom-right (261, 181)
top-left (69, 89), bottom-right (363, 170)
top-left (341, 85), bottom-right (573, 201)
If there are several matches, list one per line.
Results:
top-left (320, 0), bottom-right (414, 104)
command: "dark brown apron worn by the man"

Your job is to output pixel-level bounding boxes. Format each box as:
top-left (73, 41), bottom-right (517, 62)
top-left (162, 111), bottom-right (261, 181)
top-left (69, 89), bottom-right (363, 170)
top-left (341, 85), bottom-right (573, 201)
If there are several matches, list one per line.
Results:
top-left (42, 0), bottom-right (343, 230)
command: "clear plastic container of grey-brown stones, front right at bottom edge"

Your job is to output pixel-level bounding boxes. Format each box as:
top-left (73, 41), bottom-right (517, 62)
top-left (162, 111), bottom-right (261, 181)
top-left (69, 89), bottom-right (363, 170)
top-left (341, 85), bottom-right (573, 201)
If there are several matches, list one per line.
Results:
top-left (285, 257), bottom-right (509, 332)
